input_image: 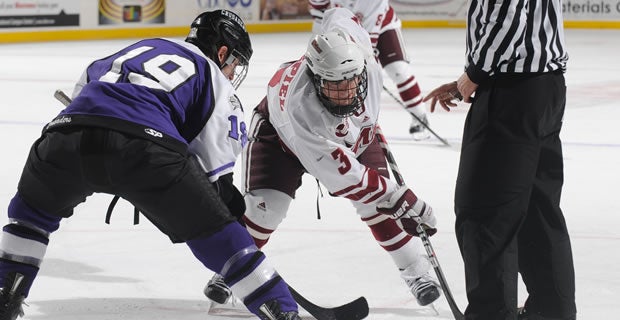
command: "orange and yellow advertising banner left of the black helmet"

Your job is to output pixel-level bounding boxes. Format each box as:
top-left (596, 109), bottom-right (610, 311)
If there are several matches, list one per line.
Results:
top-left (99, 0), bottom-right (166, 25)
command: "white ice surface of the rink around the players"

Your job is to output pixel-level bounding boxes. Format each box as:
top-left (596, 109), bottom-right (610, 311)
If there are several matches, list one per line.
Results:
top-left (0, 29), bottom-right (620, 320)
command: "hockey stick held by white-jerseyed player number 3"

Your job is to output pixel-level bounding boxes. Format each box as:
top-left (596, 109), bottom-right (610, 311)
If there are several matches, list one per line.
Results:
top-left (376, 126), bottom-right (465, 320)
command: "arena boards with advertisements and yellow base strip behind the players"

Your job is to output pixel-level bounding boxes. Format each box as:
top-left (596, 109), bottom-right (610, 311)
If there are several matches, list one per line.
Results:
top-left (0, 0), bottom-right (620, 43)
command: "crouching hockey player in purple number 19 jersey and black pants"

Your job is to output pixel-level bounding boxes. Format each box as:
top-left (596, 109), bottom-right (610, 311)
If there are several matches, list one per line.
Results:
top-left (0, 10), bottom-right (300, 320)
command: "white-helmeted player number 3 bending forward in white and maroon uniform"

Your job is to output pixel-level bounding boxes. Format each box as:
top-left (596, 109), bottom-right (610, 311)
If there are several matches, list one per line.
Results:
top-left (205, 8), bottom-right (440, 305)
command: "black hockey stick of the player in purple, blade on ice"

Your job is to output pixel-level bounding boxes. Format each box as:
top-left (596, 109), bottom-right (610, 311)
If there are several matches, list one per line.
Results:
top-left (54, 90), bottom-right (369, 320)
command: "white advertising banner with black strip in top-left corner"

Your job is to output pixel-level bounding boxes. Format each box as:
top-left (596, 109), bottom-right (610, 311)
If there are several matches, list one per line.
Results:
top-left (0, 0), bottom-right (80, 29)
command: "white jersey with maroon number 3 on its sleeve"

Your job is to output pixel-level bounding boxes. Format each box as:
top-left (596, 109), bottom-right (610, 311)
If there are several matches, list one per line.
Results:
top-left (267, 59), bottom-right (398, 204)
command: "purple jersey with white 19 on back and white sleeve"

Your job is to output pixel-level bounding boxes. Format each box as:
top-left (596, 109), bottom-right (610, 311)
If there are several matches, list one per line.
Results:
top-left (48, 39), bottom-right (247, 181)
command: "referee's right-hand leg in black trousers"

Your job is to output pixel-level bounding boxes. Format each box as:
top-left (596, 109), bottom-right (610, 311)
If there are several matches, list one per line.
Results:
top-left (519, 74), bottom-right (576, 319)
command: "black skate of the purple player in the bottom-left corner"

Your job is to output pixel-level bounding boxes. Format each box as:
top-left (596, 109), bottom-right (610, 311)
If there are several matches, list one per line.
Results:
top-left (0, 272), bottom-right (26, 320)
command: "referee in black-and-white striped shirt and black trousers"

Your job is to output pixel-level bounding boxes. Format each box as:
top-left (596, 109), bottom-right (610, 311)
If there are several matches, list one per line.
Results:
top-left (425, 0), bottom-right (576, 320)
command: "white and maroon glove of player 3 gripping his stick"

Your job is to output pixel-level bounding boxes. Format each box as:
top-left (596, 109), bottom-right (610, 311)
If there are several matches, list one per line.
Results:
top-left (377, 186), bottom-right (437, 236)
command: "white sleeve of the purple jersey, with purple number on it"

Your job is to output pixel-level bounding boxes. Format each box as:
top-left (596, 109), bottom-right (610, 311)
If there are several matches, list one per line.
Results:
top-left (189, 60), bottom-right (247, 182)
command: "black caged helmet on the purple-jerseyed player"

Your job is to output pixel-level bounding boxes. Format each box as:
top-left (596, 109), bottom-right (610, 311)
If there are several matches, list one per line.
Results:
top-left (185, 10), bottom-right (253, 88)
